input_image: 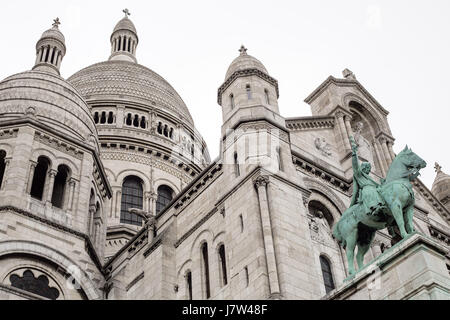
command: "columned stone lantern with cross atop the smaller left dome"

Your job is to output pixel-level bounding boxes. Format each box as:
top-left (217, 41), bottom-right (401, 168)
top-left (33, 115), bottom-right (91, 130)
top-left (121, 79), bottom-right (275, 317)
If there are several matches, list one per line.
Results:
top-left (33, 18), bottom-right (66, 75)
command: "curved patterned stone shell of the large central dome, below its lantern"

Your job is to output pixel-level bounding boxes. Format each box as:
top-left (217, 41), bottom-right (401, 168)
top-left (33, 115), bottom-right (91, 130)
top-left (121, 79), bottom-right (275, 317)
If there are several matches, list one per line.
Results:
top-left (68, 60), bottom-right (194, 126)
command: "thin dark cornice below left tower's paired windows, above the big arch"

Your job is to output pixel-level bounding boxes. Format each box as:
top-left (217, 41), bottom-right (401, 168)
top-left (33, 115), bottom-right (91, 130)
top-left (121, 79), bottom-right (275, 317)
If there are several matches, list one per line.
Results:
top-left (0, 206), bottom-right (104, 275)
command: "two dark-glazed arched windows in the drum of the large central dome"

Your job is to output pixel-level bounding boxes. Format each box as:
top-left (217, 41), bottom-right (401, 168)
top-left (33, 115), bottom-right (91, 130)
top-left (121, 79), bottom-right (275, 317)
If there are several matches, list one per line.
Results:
top-left (120, 176), bottom-right (174, 226)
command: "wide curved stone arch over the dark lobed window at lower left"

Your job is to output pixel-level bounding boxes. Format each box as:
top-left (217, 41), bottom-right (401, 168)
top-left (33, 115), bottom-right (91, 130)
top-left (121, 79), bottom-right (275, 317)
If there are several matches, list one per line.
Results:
top-left (0, 240), bottom-right (101, 300)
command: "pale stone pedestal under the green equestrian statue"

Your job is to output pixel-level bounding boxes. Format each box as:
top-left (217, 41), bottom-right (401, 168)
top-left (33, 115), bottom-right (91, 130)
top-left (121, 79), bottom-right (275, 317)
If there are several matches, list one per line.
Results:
top-left (323, 234), bottom-right (450, 300)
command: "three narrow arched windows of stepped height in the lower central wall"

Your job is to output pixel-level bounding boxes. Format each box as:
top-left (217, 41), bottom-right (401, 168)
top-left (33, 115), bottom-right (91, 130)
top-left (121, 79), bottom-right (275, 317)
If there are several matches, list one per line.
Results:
top-left (185, 242), bottom-right (228, 300)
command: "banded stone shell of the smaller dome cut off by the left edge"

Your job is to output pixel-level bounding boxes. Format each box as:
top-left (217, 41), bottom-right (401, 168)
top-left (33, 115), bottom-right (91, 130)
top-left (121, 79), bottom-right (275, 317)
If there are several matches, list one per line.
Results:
top-left (0, 71), bottom-right (98, 141)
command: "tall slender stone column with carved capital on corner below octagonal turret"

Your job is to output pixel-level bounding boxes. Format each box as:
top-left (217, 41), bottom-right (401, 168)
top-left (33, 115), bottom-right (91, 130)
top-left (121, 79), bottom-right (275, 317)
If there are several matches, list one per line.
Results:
top-left (253, 176), bottom-right (280, 295)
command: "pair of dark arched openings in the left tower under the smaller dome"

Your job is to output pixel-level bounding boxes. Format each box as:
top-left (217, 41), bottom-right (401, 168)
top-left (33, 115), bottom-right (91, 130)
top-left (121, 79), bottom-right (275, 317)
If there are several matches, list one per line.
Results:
top-left (30, 156), bottom-right (70, 209)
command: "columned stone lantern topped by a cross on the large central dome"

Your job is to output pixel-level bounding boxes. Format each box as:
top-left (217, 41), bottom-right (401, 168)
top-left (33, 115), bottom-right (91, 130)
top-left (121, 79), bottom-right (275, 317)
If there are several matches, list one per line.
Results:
top-left (109, 9), bottom-right (139, 63)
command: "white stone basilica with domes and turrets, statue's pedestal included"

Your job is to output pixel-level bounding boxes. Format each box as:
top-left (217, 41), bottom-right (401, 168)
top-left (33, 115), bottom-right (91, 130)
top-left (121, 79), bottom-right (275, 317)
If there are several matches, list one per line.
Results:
top-left (0, 10), bottom-right (450, 299)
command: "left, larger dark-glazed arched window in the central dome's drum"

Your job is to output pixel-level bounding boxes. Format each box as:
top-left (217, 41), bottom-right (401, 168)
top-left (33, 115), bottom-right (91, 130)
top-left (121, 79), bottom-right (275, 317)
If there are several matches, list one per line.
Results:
top-left (120, 176), bottom-right (143, 226)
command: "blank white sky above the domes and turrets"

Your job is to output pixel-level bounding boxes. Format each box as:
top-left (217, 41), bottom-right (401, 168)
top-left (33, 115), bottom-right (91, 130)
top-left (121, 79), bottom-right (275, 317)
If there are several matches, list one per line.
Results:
top-left (0, 0), bottom-right (450, 188)
